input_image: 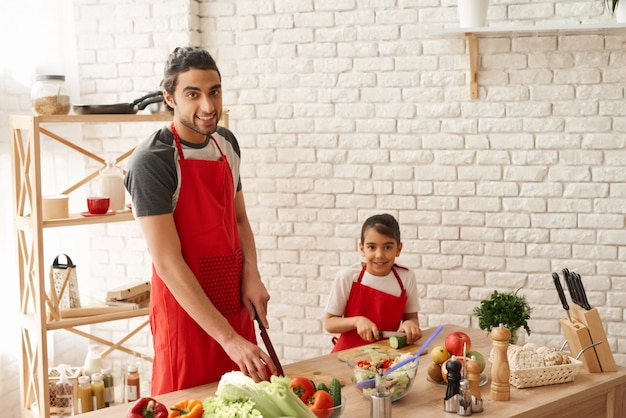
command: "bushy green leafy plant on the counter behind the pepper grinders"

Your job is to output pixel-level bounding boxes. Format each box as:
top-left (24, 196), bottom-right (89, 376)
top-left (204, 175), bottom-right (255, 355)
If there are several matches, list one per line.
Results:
top-left (474, 289), bottom-right (532, 344)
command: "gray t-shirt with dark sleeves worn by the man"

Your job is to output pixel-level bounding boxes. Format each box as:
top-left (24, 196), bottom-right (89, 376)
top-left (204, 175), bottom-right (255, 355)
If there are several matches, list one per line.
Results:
top-left (124, 126), bottom-right (241, 217)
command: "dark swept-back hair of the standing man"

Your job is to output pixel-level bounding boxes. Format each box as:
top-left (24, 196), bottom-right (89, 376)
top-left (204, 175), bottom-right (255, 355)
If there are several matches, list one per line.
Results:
top-left (162, 46), bottom-right (222, 96)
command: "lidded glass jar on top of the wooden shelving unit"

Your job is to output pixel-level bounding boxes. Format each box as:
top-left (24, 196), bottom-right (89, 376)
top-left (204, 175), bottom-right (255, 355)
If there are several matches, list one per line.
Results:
top-left (30, 75), bottom-right (70, 115)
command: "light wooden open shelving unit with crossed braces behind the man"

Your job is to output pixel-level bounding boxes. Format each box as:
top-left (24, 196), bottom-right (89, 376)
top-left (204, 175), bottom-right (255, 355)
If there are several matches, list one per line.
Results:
top-left (10, 112), bottom-right (172, 417)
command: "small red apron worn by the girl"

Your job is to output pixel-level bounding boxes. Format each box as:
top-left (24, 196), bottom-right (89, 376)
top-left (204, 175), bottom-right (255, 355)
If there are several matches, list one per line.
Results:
top-left (332, 264), bottom-right (408, 353)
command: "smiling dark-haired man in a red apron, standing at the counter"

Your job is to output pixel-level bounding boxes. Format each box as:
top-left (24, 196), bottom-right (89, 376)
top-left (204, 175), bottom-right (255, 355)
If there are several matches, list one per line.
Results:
top-left (125, 47), bottom-right (276, 395)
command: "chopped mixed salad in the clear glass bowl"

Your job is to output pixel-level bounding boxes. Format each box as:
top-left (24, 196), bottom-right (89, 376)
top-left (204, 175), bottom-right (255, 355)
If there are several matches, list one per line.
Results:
top-left (346, 350), bottom-right (419, 402)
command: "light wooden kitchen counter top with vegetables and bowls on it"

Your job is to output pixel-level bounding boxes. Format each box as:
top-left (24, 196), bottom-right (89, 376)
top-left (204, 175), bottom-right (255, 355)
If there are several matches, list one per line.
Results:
top-left (83, 325), bottom-right (626, 418)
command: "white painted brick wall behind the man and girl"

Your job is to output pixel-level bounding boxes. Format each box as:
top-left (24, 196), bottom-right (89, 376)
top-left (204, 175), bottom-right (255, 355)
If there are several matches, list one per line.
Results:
top-left (0, 0), bottom-right (626, 414)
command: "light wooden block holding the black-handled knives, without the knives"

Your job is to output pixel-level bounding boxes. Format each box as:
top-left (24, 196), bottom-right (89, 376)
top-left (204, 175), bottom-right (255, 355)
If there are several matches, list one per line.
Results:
top-left (561, 304), bottom-right (617, 373)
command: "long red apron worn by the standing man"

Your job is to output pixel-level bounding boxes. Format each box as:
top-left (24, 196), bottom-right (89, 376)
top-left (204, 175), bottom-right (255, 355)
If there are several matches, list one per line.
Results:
top-left (150, 122), bottom-right (256, 396)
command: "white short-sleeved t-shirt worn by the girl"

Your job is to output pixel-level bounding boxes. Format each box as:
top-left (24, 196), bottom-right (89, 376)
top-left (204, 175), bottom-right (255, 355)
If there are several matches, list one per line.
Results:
top-left (326, 263), bottom-right (419, 316)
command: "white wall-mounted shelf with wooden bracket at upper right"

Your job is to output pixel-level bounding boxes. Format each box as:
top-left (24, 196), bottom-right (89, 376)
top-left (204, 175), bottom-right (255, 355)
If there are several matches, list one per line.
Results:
top-left (422, 23), bottom-right (626, 99)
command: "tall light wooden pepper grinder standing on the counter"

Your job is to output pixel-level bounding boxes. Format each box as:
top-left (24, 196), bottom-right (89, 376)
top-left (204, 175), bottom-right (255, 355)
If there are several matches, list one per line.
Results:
top-left (491, 324), bottom-right (511, 401)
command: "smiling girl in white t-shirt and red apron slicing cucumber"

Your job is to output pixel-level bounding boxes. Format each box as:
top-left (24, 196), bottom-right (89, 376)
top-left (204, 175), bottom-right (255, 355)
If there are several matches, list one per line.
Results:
top-left (324, 214), bottom-right (422, 352)
